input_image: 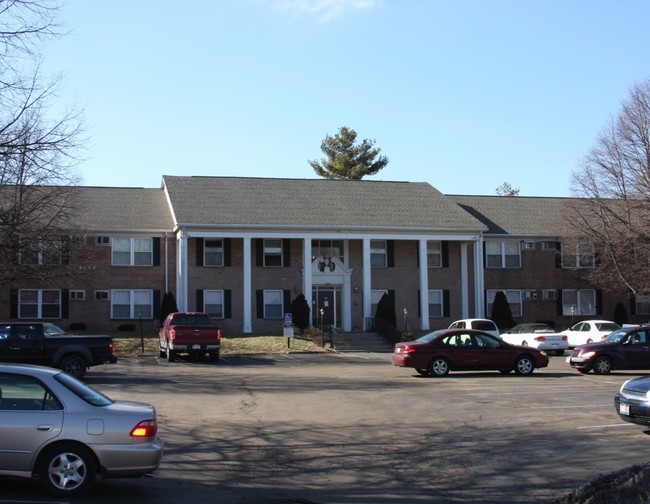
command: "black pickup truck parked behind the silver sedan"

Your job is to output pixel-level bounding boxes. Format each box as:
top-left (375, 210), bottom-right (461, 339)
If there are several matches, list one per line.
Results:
top-left (0, 322), bottom-right (117, 378)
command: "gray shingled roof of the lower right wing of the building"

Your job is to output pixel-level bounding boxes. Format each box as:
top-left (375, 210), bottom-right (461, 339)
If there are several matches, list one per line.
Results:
top-left (448, 195), bottom-right (574, 237)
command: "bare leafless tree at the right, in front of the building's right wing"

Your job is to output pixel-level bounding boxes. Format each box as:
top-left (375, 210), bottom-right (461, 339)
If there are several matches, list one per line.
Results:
top-left (563, 80), bottom-right (650, 294)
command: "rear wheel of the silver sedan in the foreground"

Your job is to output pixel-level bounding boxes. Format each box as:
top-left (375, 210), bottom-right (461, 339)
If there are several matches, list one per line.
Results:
top-left (38, 443), bottom-right (97, 497)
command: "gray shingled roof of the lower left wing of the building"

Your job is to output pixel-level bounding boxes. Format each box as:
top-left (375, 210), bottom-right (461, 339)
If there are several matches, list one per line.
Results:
top-left (75, 187), bottom-right (174, 231)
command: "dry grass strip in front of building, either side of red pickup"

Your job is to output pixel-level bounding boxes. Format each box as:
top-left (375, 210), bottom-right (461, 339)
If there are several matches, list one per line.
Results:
top-left (112, 333), bottom-right (330, 357)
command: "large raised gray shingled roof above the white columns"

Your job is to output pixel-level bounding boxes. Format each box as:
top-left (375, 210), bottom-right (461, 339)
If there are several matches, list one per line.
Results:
top-left (163, 176), bottom-right (485, 231)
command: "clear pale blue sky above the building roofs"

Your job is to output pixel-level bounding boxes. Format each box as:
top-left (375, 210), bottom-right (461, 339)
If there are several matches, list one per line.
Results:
top-left (43, 0), bottom-right (650, 196)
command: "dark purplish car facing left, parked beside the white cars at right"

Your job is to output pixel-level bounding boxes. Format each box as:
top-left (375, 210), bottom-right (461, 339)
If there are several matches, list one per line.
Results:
top-left (567, 325), bottom-right (650, 374)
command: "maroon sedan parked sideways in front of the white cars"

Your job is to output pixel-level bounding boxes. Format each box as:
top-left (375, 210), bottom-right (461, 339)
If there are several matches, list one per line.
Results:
top-left (391, 329), bottom-right (548, 376)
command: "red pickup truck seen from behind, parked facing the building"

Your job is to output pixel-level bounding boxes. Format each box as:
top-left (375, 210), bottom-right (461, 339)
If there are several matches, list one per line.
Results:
top-left (158, 312), bottom-right (221, 362)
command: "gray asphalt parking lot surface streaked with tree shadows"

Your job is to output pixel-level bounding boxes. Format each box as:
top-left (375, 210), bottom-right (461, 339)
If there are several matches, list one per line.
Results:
top-left (0, 353), bottom-right (650, 504)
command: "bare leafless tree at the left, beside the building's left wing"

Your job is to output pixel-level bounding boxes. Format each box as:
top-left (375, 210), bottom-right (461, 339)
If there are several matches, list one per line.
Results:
top-left (0, 0), bottom-right (88, 284)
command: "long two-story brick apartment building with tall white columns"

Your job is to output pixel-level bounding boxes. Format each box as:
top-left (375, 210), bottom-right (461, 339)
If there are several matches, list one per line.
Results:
top-left (0, 176), bottom-right (649, 333)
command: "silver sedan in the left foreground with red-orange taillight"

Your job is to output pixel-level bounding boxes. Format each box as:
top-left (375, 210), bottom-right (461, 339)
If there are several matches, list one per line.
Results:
top-left (0, 363), bottom-right (163, 497)
